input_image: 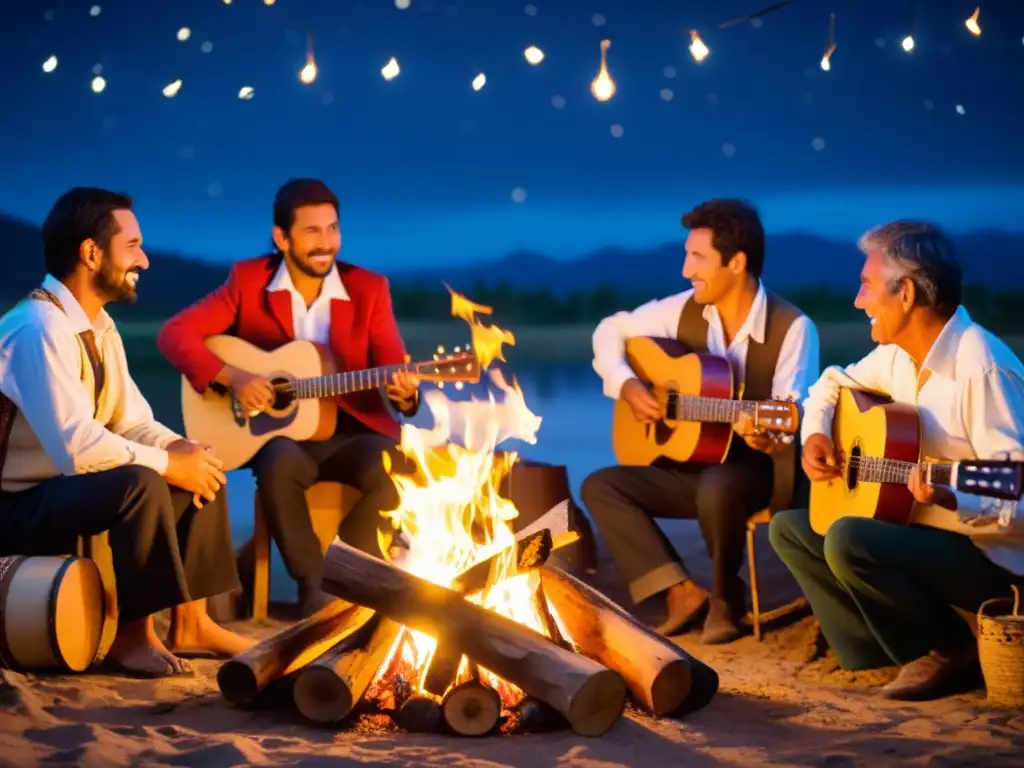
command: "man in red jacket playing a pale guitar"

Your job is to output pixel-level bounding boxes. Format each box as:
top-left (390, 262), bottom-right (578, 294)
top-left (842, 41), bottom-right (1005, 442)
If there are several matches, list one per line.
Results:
top-left (157, 179), bottom-right (419, 615)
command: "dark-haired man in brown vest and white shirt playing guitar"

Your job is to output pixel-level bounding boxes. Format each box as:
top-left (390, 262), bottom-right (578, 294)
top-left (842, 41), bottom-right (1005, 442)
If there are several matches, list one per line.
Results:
top-left (582, 200), bottom-right (818, 644)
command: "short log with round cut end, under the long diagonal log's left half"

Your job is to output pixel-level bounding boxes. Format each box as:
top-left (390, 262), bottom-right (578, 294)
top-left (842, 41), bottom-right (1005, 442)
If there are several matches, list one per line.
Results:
top-left (292, 608), bottom-right (402, 723)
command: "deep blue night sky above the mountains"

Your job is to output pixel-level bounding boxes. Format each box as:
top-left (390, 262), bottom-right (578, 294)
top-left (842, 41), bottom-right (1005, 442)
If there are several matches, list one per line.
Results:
top-left (0, 0), bottom-right (1024, 269)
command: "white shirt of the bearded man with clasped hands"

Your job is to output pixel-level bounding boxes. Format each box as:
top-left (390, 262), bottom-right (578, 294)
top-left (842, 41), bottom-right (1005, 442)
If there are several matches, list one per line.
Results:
top-left (0, 275), bottom-right (180, 490)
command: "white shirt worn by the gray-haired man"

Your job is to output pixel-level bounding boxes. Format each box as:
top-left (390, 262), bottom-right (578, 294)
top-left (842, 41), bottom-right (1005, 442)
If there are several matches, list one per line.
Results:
top-left (801, 307), bottom-right (1024, 575)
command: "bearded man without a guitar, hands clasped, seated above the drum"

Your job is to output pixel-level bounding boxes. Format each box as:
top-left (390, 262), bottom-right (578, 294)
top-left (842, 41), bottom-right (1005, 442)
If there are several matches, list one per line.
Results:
top-left (0, 187), bottom-right (251, 677)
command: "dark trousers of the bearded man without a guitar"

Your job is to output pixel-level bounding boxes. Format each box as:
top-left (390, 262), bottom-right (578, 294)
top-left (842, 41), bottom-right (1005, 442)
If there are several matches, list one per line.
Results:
top-left (0, 466), bottom-right (239, 623)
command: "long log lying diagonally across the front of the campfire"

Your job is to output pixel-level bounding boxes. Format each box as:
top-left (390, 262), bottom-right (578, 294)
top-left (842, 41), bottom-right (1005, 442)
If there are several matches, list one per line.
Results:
top-left (321, 543), bottom-right (626, 736)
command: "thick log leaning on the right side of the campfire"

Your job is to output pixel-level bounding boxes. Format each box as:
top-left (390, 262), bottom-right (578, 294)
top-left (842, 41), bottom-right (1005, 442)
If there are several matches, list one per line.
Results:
top-left (541, 565), bottom-right (718, 716)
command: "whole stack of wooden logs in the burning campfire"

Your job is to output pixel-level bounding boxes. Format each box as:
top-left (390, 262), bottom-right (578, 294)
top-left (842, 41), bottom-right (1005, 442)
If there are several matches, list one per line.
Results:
top-left (218, 531), bottom-right (718, 736)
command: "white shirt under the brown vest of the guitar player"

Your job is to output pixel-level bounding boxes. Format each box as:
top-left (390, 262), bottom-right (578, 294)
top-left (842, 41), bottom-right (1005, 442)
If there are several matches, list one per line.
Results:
top-left (593, 285), bottom-right (821, 399)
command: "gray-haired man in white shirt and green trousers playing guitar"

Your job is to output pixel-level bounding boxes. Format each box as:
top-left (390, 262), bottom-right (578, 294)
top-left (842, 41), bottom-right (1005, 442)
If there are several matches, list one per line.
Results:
top-left (770, 220), bottom-right (1024, 699)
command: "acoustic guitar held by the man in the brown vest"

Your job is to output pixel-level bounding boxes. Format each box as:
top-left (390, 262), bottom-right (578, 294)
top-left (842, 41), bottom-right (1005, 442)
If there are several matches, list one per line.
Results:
top-left (611, 336), bottom-right (800, 465)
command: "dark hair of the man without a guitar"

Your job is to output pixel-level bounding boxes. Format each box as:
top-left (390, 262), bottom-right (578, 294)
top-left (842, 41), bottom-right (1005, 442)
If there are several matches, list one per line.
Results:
top-left (43, 186), bottom-right (132, 280)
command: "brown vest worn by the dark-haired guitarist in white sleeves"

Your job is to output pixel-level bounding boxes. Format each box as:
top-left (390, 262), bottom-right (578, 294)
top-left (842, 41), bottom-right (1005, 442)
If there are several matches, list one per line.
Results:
top-left (677, 291), bottom-right (809, 512)
